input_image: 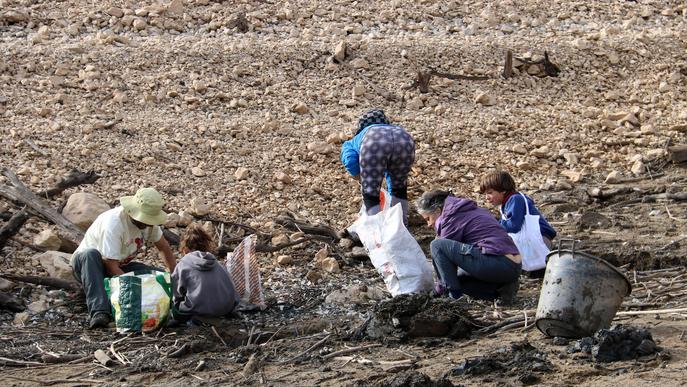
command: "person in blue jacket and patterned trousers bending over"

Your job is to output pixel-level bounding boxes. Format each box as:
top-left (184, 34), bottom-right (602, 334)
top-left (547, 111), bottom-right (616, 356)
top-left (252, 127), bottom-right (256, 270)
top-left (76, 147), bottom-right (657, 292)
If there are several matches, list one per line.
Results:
top-left (341, 109), bottom-right (415, 224)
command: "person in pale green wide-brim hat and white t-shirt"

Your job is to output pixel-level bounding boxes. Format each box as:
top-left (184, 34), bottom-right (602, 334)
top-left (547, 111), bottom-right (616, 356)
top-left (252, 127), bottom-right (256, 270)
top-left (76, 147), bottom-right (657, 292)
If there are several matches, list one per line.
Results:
top-left (70, 188), bottom-right (176, 328)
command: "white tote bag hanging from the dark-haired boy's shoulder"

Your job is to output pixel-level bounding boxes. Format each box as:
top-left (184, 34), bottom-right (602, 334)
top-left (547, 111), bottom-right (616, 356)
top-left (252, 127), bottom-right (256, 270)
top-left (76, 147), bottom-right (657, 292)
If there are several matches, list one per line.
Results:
top-left (499, 193), bottom-right (549, 271)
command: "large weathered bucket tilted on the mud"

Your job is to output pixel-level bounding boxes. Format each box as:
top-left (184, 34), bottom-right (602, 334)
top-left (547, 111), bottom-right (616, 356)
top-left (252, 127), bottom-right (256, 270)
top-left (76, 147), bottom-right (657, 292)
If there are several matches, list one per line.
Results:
top-left (535, 240), bottom-right (632, 338)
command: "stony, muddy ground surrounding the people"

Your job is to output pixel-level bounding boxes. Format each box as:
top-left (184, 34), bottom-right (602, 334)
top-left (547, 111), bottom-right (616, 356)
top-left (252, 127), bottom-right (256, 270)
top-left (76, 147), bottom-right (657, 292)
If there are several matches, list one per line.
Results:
top-left (0, 0), bottom-right (687, 385)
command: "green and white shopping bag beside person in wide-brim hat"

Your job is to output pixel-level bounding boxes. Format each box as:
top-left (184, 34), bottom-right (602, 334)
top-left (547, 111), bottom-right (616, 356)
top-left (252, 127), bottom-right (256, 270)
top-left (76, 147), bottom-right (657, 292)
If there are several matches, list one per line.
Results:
top-left (105, 271), bottom-right (172, 332)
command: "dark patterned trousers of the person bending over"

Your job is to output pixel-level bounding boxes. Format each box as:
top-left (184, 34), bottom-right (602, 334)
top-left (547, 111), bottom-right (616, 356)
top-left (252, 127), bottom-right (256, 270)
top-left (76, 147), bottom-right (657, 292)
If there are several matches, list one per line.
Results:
top-left (360, 125), bottom-right (415, 211)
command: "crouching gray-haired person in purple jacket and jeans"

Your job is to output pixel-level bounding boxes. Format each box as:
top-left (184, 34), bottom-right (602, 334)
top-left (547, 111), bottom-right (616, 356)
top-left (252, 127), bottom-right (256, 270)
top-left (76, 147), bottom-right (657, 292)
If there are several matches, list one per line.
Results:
top-left (416, 190), bottom-right (522, 304)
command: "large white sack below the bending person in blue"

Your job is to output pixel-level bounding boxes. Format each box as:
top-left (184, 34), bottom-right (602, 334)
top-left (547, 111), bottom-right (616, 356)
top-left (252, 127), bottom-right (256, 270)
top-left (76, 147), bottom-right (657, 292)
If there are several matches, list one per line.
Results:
top-left (348, 204), bottom-right (433, 296)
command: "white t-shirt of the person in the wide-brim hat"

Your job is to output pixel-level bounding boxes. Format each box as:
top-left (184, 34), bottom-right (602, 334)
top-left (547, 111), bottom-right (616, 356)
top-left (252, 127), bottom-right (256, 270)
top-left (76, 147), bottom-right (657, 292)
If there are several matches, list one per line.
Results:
top-left (72, 206), bottom-right (162, 265)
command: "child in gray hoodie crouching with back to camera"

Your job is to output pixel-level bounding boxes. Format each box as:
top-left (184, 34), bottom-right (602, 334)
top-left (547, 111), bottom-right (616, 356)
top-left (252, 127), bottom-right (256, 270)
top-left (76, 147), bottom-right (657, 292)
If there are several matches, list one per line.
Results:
top-left (170, 224), bottom-right (238, 325)
